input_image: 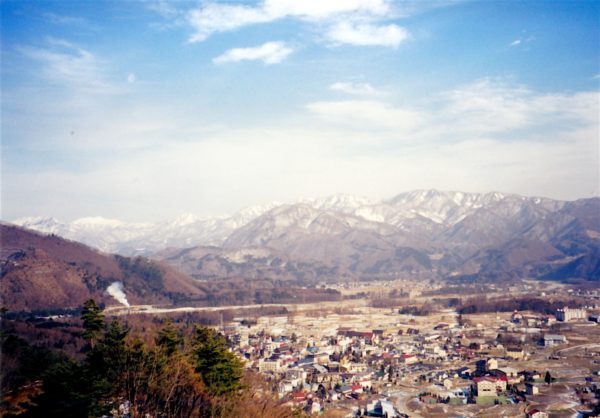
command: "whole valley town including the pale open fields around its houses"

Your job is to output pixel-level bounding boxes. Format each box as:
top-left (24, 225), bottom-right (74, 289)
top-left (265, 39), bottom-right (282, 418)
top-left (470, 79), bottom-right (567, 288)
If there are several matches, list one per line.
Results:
top-left (209, 282), bottom-right (600, 418)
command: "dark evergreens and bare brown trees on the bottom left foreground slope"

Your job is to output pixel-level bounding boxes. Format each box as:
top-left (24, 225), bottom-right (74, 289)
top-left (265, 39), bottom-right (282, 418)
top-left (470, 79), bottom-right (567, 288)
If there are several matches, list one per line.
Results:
top-left (0, 300), bottom-right (291, 418)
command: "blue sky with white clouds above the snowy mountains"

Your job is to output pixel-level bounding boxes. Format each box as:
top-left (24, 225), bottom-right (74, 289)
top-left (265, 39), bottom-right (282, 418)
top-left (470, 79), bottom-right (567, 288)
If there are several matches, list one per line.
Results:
top-left (0, 0), bottom-right (600, 221)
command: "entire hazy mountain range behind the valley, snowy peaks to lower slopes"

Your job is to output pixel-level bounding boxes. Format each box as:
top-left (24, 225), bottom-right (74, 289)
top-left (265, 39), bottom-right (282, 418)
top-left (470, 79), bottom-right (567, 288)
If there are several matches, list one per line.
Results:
top-left (10, 190), bottom-right (600, 282)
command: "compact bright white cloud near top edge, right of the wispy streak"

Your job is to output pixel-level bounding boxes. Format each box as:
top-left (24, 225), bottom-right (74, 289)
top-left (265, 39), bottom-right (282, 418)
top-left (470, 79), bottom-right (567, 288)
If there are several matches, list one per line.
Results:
top-left (327, 22), bottom-right (409, 48)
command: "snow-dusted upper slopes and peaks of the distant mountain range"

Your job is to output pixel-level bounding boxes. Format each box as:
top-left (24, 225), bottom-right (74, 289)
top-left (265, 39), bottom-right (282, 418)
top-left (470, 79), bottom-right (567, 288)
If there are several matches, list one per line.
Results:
top-left (9, 190), bottom-right (564, 255)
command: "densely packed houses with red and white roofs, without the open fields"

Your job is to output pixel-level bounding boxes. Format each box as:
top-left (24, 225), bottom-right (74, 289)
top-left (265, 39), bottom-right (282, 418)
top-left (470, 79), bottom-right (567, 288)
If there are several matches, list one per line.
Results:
top-left (222, 308), bottom-right (596, 418)
